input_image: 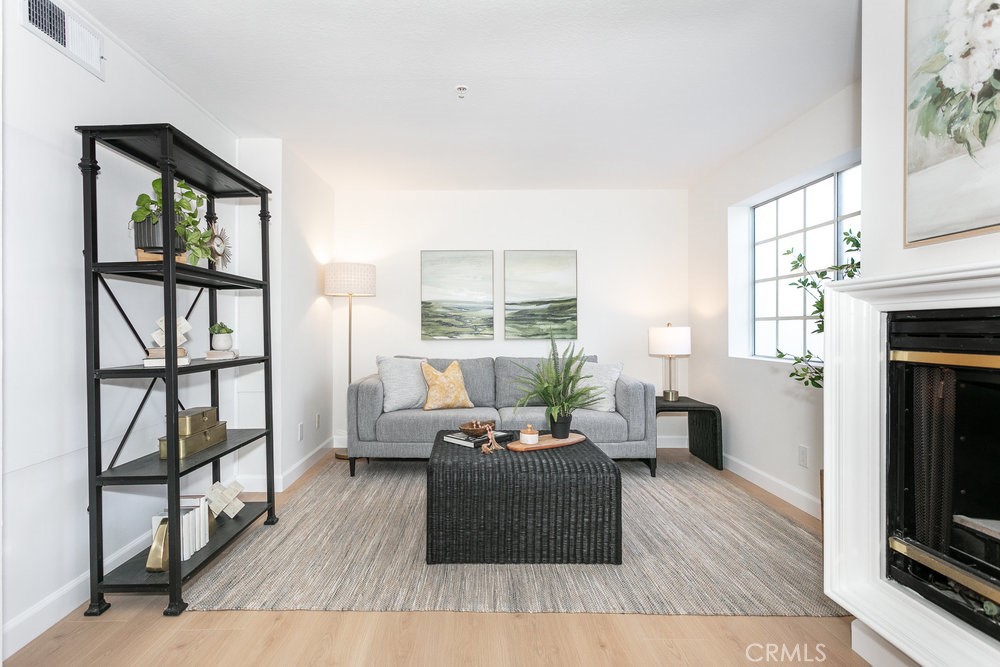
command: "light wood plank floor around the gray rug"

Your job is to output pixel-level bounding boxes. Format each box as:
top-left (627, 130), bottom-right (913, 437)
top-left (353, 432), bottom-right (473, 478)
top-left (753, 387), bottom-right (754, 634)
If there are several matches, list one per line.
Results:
top-left (4, 450), bottom-right (865, 667)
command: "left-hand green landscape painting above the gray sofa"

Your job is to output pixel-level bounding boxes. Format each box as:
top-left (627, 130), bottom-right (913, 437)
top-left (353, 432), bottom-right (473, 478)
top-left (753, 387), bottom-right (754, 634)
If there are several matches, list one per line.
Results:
top-left (420, 250), bottom-right (493, 340)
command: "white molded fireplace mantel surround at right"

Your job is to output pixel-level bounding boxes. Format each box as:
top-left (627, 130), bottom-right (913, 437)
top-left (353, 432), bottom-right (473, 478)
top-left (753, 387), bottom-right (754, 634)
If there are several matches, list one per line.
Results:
top-left (824, 264), bottom-right (1000, 666)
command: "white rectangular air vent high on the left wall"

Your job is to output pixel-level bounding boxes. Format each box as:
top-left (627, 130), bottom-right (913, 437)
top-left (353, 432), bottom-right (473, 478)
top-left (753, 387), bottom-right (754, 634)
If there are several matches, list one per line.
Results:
top-left (21, 0), bottom-right (104, 79)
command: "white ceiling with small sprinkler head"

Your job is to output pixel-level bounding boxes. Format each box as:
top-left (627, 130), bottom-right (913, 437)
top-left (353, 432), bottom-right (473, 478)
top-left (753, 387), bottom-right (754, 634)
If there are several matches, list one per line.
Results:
top-left (77, 0), bottom-right (860, 189)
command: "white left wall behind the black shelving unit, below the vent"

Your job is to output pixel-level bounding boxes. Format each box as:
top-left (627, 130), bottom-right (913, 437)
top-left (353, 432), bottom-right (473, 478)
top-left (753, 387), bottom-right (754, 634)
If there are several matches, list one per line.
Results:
top-left (2, 2), bottom-right (243, 655)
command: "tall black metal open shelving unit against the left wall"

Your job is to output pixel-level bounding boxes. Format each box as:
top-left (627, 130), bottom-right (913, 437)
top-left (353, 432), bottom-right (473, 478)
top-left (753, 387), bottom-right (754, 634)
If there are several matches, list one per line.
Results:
top-left (76, 124), bottom-right (278, 616)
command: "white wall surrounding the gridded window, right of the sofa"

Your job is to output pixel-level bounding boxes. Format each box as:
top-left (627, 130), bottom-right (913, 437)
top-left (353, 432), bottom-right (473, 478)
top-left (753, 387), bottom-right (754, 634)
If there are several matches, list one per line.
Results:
top-left (689, 79), bottom-right (860, 516)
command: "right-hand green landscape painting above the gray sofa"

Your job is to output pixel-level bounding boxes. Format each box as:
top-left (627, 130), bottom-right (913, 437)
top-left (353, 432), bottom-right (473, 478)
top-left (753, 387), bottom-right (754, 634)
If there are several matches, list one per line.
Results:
top-left (503, 250), bottom-right (576, 340)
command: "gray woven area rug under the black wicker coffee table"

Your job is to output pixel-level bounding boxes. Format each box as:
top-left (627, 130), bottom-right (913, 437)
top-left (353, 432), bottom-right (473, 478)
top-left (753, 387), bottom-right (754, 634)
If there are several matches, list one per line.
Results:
top-left (185, 452), bottom-right (846, 616)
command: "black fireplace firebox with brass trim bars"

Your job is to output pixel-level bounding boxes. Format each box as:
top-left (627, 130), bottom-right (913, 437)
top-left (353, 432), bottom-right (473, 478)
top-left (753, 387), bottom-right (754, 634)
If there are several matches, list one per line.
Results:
top-left (886, 308), bottom-right (1000, 639)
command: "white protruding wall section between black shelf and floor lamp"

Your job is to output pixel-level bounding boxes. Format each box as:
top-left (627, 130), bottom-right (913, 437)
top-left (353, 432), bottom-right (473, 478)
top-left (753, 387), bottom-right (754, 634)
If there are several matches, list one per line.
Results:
top-left (235, 138), bottom-right (333, 491)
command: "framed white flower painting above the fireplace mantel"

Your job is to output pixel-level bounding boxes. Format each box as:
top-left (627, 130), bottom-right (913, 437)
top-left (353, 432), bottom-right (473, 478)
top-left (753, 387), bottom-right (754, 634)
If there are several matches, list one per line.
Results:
top-left (905, 0), bottom-right (1000, 246)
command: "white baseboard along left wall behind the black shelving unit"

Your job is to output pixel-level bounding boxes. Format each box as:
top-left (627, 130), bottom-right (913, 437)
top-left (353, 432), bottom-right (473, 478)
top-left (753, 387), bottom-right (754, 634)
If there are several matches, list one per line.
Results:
top-left (3, 531), bottom-right (150, 660)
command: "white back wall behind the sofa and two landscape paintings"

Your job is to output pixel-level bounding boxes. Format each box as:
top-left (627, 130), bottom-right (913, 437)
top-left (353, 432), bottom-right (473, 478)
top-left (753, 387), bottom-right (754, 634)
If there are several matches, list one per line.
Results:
top-left (332, 191), bottom-right (688, 438)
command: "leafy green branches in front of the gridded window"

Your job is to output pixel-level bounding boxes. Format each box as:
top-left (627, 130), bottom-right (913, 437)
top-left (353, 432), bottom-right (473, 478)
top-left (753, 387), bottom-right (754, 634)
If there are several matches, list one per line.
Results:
top-left (777, 229), bottom-right (861, 389)
